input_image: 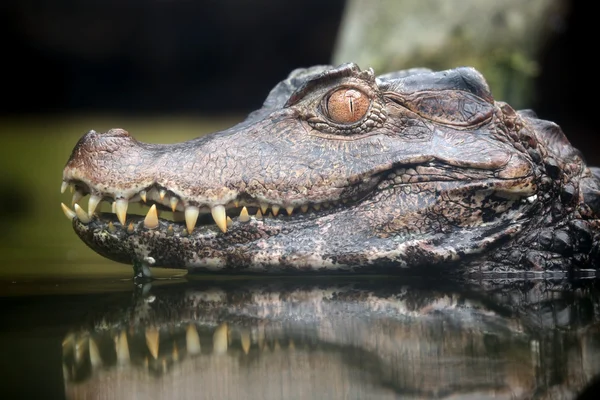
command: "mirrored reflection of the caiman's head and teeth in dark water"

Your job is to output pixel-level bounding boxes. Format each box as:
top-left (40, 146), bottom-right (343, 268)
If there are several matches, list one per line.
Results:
top-left (63, 278), bottom-right (600, 399)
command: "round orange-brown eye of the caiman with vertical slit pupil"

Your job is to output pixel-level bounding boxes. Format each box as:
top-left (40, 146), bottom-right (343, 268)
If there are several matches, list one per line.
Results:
top-left (327, 88), bottom-right (371, 124)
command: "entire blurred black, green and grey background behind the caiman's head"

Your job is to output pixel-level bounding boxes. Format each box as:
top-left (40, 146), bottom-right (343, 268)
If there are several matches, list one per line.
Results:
top-left (0, 0), bottom-right (600, 277)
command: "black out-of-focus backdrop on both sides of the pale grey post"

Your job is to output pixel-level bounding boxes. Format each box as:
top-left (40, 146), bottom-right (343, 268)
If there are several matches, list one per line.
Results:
top-left (0, 0), bottom-right (600, 163)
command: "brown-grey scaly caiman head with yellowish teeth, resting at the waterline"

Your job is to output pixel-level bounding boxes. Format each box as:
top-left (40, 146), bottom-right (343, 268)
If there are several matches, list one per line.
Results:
top-left (62, 64), bottom-right (600, 272)
